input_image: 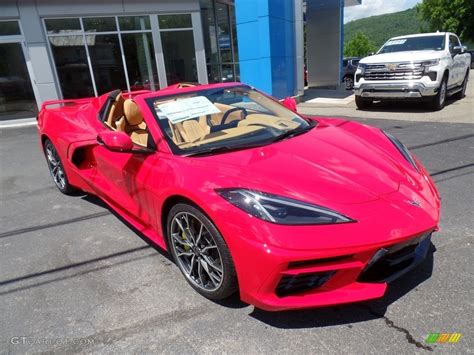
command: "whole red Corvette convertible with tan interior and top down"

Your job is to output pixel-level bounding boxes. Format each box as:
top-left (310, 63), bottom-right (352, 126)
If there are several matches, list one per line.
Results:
top-left (38, 83), bottom-right (440, 311)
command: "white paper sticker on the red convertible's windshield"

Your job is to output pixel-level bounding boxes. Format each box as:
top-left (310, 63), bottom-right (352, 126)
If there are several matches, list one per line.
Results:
top-left (155, 96), bottom-right (221, 123)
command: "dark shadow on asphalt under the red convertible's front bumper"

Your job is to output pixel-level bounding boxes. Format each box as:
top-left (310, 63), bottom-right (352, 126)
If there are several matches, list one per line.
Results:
top-left (250, 244), bottom-right (436, 329)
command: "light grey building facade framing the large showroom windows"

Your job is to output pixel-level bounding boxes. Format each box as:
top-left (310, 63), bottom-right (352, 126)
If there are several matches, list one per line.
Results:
top-left (0, 0), bottom-right (202, 105)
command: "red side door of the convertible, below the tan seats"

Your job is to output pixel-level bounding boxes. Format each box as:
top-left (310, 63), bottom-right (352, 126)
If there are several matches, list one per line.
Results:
top-left (94, 110), bottom-right (159, 231)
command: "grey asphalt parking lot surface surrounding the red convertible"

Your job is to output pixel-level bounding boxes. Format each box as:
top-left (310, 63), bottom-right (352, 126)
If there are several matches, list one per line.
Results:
top-left (0, 82), bottom-right (474, 354)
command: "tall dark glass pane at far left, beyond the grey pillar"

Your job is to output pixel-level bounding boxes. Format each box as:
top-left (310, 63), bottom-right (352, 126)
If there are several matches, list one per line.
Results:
top-left (0, 43), bottom-right (38, 121)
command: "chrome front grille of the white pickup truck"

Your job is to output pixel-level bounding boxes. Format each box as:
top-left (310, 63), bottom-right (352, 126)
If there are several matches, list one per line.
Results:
top-left (364, 63), bottom-right (424, 80)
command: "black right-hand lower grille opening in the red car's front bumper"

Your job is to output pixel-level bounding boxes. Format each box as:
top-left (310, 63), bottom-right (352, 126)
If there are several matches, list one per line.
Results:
top-left (357, 233), bottom-right (431, 282)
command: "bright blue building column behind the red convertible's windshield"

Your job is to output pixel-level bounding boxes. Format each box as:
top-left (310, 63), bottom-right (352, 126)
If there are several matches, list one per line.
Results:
top-left (235, 0), bottom-right (296, 98)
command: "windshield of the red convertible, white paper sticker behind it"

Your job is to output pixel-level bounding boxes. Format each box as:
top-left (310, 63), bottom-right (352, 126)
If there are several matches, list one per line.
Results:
top-left (147, 85), bottom-right (316, 155)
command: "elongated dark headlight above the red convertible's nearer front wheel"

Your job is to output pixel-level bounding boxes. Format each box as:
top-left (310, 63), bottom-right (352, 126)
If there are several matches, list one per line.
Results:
top-left (216, 188), bottom-right (355, 225)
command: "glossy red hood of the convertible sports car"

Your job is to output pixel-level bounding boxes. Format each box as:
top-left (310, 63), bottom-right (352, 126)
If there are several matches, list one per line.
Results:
top-left (192, 122), bottom-right (405, 207)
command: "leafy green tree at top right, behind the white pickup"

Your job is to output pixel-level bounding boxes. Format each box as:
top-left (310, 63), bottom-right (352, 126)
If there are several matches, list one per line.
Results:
top-left (417, 0), bottom-right (474, 42)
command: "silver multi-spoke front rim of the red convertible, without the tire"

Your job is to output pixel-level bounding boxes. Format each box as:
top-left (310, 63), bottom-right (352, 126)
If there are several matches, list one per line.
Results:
top-left (170, 212), bottom-right (224, 292)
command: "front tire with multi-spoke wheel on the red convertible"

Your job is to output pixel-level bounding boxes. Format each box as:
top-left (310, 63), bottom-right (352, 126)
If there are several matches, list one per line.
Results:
top-left (166, 203), bottom-right (238, 300)
